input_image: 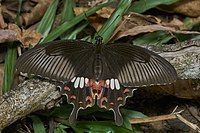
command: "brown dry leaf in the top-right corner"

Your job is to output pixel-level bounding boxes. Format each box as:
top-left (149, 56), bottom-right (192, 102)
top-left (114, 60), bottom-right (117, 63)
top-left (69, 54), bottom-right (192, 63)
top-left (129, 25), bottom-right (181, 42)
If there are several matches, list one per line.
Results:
top-left (158, 0), bottom-right (200, 17)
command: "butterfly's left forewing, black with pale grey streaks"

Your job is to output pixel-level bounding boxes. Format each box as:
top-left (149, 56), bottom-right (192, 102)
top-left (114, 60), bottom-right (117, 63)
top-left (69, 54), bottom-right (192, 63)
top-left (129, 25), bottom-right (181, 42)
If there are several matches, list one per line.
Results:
top-left (15, 40), bottom-right (94, 82)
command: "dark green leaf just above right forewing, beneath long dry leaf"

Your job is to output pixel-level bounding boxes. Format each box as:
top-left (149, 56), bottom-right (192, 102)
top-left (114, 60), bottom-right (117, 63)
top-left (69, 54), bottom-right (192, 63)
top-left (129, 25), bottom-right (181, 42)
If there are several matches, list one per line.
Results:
top-left (133, 31), bottom-right (173, 45)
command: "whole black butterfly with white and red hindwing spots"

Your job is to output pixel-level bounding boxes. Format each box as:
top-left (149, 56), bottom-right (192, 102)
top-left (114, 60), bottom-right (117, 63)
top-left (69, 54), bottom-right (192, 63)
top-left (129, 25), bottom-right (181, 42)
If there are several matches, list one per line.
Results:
top-left (16, 37), bottom-right (177, 125)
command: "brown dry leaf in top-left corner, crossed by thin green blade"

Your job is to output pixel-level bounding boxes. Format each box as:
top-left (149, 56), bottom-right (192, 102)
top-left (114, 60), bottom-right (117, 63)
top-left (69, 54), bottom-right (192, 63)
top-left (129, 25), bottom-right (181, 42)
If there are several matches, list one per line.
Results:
top-left (2, 0), bottom-right (52, 26)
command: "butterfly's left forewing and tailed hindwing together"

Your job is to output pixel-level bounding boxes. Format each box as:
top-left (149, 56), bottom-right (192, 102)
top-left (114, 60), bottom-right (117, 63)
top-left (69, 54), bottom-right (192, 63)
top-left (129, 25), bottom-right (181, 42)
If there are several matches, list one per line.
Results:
top-left (15, 40), bottom-right (95, 123)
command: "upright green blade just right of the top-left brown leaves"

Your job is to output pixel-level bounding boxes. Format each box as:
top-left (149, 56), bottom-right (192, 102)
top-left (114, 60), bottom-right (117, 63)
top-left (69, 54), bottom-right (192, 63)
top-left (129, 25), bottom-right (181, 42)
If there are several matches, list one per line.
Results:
top-left (36, 0), bottom-right (59, 38)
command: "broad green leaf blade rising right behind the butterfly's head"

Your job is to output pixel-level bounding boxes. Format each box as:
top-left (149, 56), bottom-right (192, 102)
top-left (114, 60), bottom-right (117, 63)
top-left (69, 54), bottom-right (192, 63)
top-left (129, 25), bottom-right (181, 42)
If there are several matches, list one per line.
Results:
top-left (93, 0), bottom-right (132, 43)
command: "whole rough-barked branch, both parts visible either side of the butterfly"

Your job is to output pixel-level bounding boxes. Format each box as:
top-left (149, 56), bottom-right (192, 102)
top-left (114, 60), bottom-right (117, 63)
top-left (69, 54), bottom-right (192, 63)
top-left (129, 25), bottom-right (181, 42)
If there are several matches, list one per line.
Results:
top-left (0, 41), bottom-right (200, 130)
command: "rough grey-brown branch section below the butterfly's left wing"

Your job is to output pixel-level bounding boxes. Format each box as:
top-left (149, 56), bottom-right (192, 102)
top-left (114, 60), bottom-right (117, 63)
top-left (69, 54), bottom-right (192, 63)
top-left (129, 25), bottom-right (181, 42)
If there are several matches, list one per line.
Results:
top-left (0, 79), bottom-right (60, 130)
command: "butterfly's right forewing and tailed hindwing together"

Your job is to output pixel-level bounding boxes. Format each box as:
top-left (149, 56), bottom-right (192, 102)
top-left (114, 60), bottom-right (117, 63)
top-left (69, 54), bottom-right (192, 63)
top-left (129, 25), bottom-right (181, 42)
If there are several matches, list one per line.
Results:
top-left (97, 44), bottom-right (177, 125)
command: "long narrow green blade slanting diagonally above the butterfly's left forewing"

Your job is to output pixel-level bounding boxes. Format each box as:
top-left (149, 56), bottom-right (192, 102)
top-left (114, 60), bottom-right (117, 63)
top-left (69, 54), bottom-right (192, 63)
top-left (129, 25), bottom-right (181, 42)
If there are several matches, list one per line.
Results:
top-left (42, 0), bottom-right (113, 43)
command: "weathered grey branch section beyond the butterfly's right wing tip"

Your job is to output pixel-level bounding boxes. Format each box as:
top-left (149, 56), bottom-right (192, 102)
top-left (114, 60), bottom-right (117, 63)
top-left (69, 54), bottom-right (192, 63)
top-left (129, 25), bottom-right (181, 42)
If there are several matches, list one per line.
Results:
top-left (147, 41), bottom-right (200, 79)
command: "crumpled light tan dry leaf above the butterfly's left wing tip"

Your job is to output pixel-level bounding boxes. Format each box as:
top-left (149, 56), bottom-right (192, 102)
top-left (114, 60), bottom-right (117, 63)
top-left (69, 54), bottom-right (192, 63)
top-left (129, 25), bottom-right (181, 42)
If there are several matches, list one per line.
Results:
top-left (8, 24), bottom-right (42, 48)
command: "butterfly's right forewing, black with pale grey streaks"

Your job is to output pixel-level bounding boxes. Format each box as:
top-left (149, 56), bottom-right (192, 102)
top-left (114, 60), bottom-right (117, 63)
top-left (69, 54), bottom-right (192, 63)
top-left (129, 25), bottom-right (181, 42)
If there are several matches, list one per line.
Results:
top-left (102, 43), bottom-right (177, 87)
